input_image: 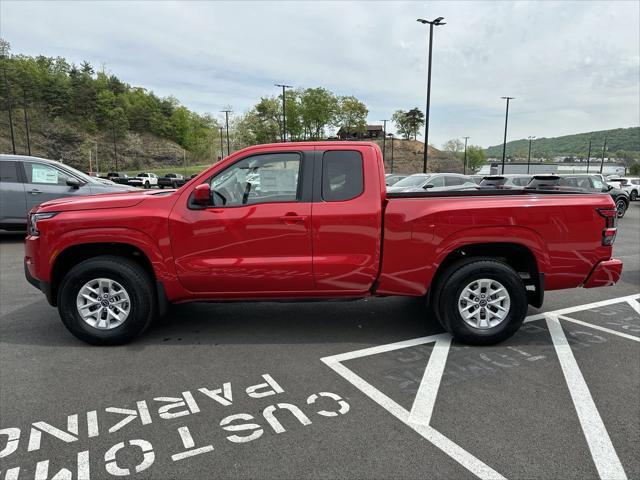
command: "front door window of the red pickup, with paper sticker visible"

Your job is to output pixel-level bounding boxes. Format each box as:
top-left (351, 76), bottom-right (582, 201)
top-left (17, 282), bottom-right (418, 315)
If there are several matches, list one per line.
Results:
top-left (211, 153), bottom-right (302, 207)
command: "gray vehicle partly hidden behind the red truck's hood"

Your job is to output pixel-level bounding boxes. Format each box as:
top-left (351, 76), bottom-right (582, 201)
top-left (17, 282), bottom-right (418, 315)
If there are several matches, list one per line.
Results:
top-left (0, 154), bottom-right (137, 230)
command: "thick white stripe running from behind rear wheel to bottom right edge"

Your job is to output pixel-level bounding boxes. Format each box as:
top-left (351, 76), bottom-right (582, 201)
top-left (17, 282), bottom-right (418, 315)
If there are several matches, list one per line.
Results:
top-left (546, 314), bottom-right (627, 479)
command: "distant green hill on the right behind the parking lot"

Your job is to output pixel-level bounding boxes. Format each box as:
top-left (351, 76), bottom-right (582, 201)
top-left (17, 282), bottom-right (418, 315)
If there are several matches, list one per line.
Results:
top-left (486, 127), bottom-right (640, 158)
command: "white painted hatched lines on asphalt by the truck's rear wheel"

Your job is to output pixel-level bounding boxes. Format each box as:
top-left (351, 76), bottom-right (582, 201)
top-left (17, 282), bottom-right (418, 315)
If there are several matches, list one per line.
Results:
top-left (321, 295), bottom-right (640, 480)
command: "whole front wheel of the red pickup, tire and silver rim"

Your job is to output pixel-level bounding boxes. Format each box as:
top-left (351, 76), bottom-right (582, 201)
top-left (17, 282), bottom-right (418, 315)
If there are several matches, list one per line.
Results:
top-left (58, 255), bottom-right (156, 345)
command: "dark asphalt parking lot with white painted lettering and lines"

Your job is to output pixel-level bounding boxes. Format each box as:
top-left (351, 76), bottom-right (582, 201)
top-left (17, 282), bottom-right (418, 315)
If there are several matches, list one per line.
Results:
top-left (0, 202), bottom-right (640, 480)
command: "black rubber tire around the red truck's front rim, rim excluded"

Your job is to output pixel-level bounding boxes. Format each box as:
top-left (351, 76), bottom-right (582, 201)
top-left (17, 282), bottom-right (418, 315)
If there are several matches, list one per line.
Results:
top-left (58, 255), bottom-right (157, 345)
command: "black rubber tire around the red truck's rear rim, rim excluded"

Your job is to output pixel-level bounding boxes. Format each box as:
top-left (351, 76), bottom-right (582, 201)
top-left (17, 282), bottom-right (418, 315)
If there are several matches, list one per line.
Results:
top-left (433, 257), bottom-right (528, 345)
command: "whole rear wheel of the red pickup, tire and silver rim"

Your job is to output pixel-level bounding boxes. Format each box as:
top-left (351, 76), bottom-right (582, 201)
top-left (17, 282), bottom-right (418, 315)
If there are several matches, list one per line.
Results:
top-left (435, 259), bottom-right (528, 345)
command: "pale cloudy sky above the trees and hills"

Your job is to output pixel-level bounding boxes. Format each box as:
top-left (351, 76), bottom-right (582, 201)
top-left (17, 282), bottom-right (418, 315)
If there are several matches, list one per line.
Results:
top-left (0, 0), bottom-right (640, 146)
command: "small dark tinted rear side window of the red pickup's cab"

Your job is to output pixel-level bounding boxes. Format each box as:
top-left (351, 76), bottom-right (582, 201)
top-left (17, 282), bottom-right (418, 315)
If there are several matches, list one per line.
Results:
top-left (322, 150), bottom-right (364, 202)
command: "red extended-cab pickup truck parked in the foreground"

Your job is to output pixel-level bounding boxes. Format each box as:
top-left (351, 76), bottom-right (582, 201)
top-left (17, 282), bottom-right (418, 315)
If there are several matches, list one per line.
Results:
top-left (25, 142), bottom-right (622, 344)
